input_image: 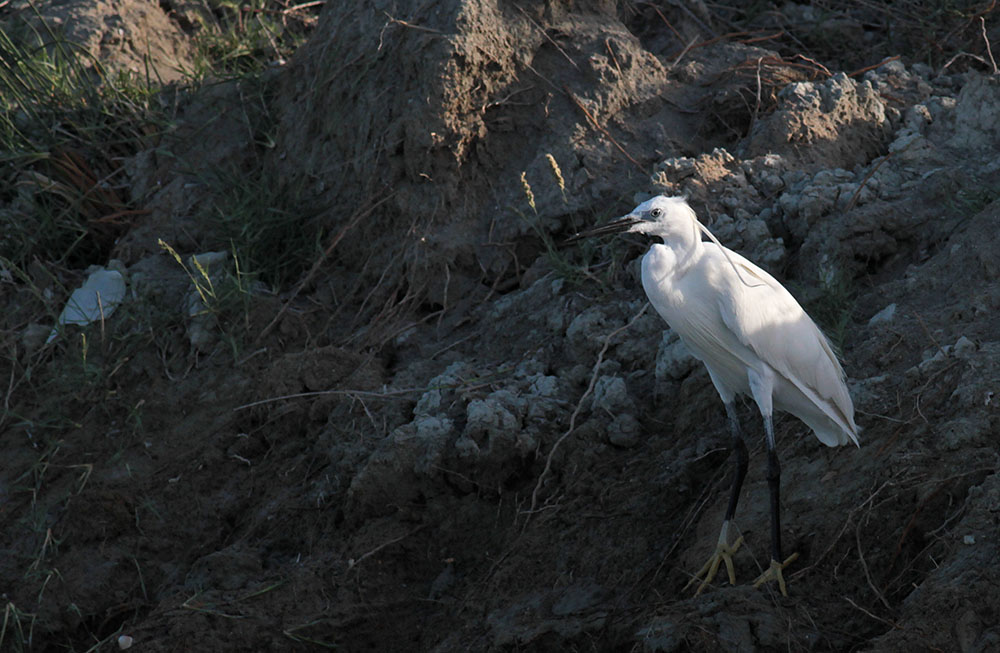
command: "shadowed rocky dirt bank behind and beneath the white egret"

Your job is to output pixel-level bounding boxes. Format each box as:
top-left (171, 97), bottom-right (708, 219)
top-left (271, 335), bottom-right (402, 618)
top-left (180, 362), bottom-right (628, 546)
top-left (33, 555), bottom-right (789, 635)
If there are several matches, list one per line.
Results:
top-left (0, 0), bottom-right (1000, 652)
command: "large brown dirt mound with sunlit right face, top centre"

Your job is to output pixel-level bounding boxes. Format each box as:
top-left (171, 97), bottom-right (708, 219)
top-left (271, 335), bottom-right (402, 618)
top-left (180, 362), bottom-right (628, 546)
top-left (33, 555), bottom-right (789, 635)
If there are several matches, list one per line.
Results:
top-left (269, 2), bottom-right (691, 314)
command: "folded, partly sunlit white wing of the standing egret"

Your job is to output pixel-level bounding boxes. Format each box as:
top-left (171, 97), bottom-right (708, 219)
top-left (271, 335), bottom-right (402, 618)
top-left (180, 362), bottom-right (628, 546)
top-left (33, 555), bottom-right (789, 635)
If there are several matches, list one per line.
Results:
top-left (714, 251), bottom-right (857, 438)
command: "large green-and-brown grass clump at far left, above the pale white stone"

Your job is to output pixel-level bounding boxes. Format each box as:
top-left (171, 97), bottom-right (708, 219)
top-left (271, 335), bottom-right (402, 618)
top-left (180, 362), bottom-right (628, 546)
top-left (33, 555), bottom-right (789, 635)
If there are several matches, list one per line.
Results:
top-left (0, 24), bottom-right (166, 267)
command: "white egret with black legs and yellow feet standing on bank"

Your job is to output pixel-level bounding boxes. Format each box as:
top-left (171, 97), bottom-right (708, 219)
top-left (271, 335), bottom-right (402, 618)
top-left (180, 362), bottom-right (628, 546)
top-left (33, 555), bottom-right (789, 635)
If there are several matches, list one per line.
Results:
top-left (570, 195), bottom-right (859, 596)
